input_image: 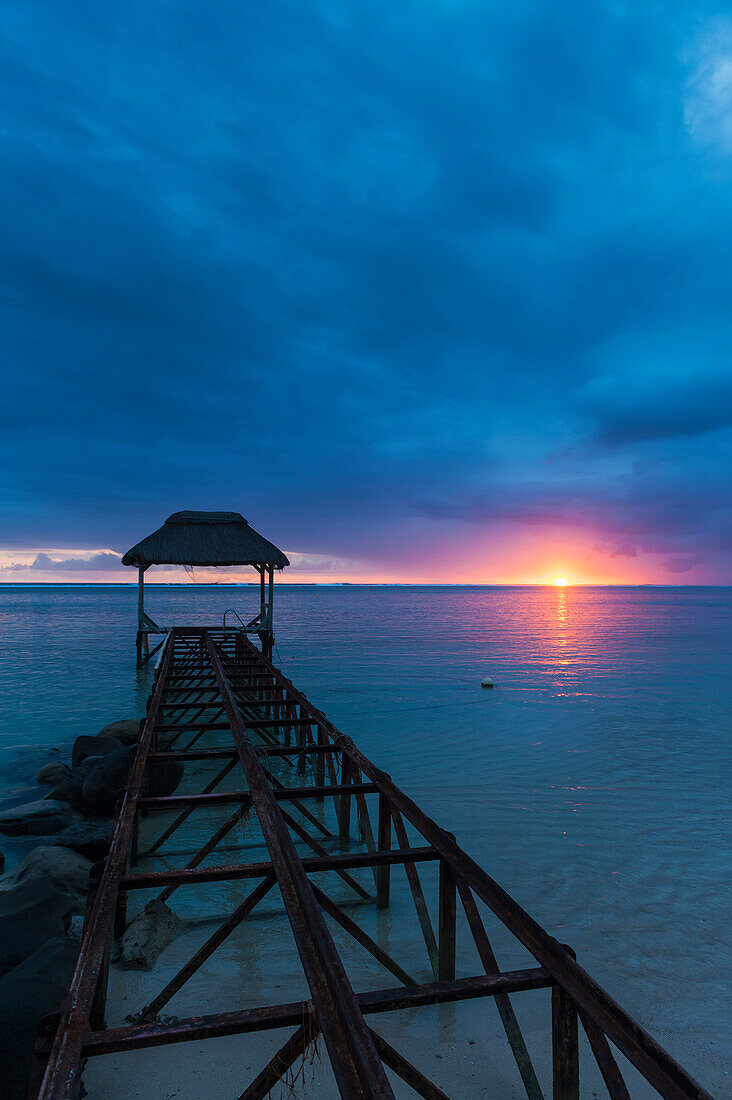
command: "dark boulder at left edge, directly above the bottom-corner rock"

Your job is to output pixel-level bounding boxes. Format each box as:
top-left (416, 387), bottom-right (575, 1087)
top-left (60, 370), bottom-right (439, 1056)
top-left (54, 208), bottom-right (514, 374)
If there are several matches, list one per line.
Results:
top-left (0, 875), bottom-right (72, 970)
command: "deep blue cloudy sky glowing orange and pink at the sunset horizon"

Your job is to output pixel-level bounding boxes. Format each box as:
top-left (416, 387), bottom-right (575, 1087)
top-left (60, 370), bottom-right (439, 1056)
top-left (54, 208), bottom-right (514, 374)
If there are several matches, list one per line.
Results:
top-left (0, 0), bottom-right (732, 584)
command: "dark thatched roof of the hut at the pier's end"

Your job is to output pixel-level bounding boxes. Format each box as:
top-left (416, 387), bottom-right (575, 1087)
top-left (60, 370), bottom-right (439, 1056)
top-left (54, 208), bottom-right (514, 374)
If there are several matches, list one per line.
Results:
top-left (122, 512), bottom-right (289, 569)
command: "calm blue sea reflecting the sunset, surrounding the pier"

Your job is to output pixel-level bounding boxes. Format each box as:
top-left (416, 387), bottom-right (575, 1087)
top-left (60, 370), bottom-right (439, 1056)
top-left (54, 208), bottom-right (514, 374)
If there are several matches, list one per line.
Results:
top-left (0, 585), bottom-right (732, 1091)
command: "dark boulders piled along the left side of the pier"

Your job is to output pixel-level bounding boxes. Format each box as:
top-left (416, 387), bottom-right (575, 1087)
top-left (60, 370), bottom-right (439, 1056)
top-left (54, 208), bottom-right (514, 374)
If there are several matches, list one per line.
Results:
top-left (0, 718), bottom-right (183, 1100)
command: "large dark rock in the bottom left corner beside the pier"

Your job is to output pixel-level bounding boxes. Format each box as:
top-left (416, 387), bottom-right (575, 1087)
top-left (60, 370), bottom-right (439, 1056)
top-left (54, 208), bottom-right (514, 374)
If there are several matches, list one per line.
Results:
top-left (0, 936), bottom-right (78, 1100)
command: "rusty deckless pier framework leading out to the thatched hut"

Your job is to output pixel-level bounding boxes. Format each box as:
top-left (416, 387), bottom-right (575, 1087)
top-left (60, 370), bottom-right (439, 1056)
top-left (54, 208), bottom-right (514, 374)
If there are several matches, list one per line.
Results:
top-left (31, 628), bottom-right (711, 1100)
